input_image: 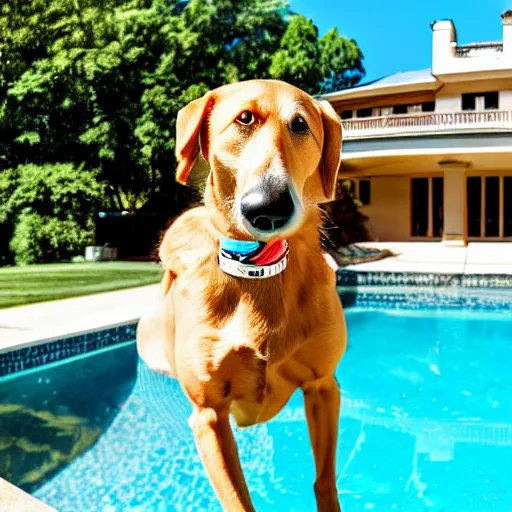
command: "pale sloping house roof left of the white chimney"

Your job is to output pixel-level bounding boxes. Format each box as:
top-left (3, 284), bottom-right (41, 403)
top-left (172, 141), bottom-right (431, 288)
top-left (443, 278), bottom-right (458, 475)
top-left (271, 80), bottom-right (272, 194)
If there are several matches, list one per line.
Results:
top-left (322, 68), bottom-right (438, 101)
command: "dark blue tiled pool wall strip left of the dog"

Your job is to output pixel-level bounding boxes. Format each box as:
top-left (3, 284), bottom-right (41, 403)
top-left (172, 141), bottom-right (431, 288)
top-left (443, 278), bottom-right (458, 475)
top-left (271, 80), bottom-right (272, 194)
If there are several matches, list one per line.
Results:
top-left (0, 323), bottom-right (137, 377)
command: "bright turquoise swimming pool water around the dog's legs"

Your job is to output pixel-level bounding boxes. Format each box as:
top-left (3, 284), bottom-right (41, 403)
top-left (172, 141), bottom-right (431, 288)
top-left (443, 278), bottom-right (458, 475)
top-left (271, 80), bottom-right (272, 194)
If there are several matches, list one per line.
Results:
top-left (0, 292), bottom-right (512, 512)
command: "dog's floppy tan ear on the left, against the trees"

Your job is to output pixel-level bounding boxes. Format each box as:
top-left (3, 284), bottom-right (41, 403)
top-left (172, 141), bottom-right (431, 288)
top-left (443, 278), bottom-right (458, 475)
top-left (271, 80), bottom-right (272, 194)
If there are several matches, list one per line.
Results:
top-left (176, 92), bottom-right (214, 185)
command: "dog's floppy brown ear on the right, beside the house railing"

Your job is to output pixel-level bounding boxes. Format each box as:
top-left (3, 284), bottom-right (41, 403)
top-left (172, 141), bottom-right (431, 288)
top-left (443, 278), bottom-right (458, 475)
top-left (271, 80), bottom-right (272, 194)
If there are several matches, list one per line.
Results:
top-left (318, 100), bottom-right (341, 201)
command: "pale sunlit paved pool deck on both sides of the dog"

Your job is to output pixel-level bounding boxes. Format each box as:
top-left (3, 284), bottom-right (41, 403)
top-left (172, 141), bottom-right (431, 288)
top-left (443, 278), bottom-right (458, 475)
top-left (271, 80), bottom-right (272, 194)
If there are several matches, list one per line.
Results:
top-left (0, 242), bottom-right (512, 352)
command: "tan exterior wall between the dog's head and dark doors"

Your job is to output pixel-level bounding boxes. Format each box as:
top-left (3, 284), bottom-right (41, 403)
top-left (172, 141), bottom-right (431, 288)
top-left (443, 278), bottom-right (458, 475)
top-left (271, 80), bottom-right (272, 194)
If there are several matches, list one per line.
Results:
top-left (361, 176), bottom-right (410, 242)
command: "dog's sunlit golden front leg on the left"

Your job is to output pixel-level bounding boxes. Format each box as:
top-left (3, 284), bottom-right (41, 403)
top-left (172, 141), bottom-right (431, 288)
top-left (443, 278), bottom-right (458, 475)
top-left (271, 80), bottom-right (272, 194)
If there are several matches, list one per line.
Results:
top-left (190, 406), bottom-right (255, 512)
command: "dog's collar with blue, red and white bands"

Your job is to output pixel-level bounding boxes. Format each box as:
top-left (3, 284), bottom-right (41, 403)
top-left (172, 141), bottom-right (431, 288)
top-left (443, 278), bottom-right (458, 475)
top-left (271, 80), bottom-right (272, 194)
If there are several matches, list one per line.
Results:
top-left (219, 238), bottom-right (289, 279)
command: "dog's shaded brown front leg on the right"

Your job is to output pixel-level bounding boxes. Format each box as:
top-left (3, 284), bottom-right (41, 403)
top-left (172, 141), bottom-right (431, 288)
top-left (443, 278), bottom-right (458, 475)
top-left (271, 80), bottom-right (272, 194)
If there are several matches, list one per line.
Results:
top-left (302, 375), bottom-right (341, 512)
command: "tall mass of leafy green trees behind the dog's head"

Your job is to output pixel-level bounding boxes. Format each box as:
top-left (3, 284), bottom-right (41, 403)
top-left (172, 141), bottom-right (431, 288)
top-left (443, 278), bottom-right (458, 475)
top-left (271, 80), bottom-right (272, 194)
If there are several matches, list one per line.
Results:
top-left (0, 0), bottom-right (364, 262)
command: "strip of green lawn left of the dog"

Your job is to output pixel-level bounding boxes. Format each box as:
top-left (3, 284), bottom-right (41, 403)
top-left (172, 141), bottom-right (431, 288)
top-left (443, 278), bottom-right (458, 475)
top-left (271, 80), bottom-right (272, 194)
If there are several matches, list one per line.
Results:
top-left (0, 261), bottom-right (162, 308)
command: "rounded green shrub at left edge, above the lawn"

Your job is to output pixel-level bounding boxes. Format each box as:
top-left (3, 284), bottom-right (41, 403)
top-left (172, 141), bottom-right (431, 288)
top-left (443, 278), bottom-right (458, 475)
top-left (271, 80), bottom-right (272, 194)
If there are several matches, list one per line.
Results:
top-left (0, 163), bottom-right (103, 264)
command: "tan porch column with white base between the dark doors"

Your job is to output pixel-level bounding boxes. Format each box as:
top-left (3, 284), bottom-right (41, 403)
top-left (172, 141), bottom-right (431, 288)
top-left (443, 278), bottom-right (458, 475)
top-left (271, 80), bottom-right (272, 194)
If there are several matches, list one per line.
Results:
top-left (443, 165), bottom-right (466, 246)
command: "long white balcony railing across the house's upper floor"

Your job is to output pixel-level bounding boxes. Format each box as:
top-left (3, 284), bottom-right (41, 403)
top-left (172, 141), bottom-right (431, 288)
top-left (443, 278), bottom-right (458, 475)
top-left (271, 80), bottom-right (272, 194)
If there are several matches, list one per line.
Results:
top-left (343, 110), bottom-right (512, 139)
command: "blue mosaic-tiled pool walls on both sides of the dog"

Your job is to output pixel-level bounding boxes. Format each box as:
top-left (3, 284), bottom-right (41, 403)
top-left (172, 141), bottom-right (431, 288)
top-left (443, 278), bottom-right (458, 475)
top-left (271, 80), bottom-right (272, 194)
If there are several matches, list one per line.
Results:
top-left (0, 269), bottom-right (512, 377)
